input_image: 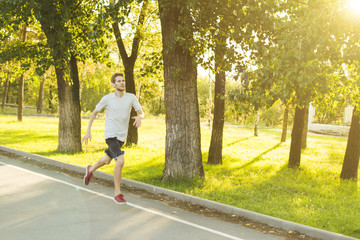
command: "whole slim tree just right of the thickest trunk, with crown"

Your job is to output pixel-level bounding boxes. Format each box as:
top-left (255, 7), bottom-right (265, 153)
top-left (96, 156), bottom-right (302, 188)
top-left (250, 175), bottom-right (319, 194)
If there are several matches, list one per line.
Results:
top-left (193, 0), bottom-right (263, 164)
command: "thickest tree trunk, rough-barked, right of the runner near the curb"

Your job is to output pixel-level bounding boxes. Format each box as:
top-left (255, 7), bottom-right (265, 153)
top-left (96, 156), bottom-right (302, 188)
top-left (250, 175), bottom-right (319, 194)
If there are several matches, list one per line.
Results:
top-left (159, 0), bottom-right (204, 180)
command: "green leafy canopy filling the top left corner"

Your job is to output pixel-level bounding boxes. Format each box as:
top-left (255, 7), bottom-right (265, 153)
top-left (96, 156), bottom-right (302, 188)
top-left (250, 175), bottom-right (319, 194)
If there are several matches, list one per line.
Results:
top-left (0, 0), bottom-right (116, 88)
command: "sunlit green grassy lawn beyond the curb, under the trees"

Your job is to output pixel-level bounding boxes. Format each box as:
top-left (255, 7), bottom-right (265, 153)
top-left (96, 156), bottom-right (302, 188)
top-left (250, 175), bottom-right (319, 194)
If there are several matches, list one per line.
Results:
top-left (0, 115), bottom-right (360, 238)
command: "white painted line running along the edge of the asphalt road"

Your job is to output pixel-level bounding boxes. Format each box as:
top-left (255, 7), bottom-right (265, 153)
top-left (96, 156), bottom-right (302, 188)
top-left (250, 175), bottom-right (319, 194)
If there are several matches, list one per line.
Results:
top-left (0, 161), bottom-right (245, 240)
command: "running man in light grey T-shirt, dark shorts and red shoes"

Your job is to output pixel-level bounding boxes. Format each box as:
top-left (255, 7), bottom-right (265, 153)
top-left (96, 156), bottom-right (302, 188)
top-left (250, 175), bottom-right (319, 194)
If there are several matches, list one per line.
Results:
top-left (82, 73), bottom-right (145, 204)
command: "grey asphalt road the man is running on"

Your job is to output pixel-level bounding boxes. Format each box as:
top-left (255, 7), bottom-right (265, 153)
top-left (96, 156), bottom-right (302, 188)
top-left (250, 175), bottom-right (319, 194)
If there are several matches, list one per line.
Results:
top-left (0, 156), bottom-right (285, 240)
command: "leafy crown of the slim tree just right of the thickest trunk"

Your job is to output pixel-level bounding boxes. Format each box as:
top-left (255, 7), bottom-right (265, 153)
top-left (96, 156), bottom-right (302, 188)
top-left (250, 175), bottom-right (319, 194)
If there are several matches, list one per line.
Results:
top-left (192, 0), bottom-right (268, 73)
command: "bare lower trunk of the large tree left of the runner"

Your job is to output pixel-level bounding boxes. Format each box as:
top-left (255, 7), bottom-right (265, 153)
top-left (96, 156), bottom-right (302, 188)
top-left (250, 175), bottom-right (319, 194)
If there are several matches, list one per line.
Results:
top-left (55, 55), bottom-right (82, 152)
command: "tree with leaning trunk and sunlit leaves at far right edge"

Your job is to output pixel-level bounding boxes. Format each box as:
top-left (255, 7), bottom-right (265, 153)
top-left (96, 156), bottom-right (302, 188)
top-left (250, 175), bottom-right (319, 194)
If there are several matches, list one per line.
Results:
top-left (332, 2), bottom-right (360, 180)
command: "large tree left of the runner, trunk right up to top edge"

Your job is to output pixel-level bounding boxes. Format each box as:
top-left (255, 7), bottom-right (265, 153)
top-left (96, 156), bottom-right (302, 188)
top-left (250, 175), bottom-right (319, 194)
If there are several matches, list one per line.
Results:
top-left (34, 0), bottom-right (82, 152)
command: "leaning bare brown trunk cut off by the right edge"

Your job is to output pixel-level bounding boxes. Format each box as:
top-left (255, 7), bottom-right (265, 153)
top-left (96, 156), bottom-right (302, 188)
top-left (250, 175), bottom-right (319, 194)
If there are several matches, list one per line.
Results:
top-left (340, 107), bottom-right (360, 180)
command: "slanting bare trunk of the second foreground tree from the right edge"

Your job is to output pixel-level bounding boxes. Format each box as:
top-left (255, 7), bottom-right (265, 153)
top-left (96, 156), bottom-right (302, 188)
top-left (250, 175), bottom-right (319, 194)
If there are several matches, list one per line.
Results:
top-left (288, 107), bottom-right (305, 168)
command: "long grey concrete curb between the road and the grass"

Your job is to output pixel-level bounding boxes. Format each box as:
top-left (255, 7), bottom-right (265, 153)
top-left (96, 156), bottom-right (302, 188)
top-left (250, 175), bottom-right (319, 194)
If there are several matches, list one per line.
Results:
top-left (0, 145), bottom-right (359, 240)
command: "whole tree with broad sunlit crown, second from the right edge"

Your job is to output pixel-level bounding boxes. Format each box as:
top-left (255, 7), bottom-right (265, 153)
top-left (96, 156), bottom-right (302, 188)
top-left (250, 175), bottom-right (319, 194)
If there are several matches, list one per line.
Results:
top-left (253, 0), bottom-right (339, 168)
